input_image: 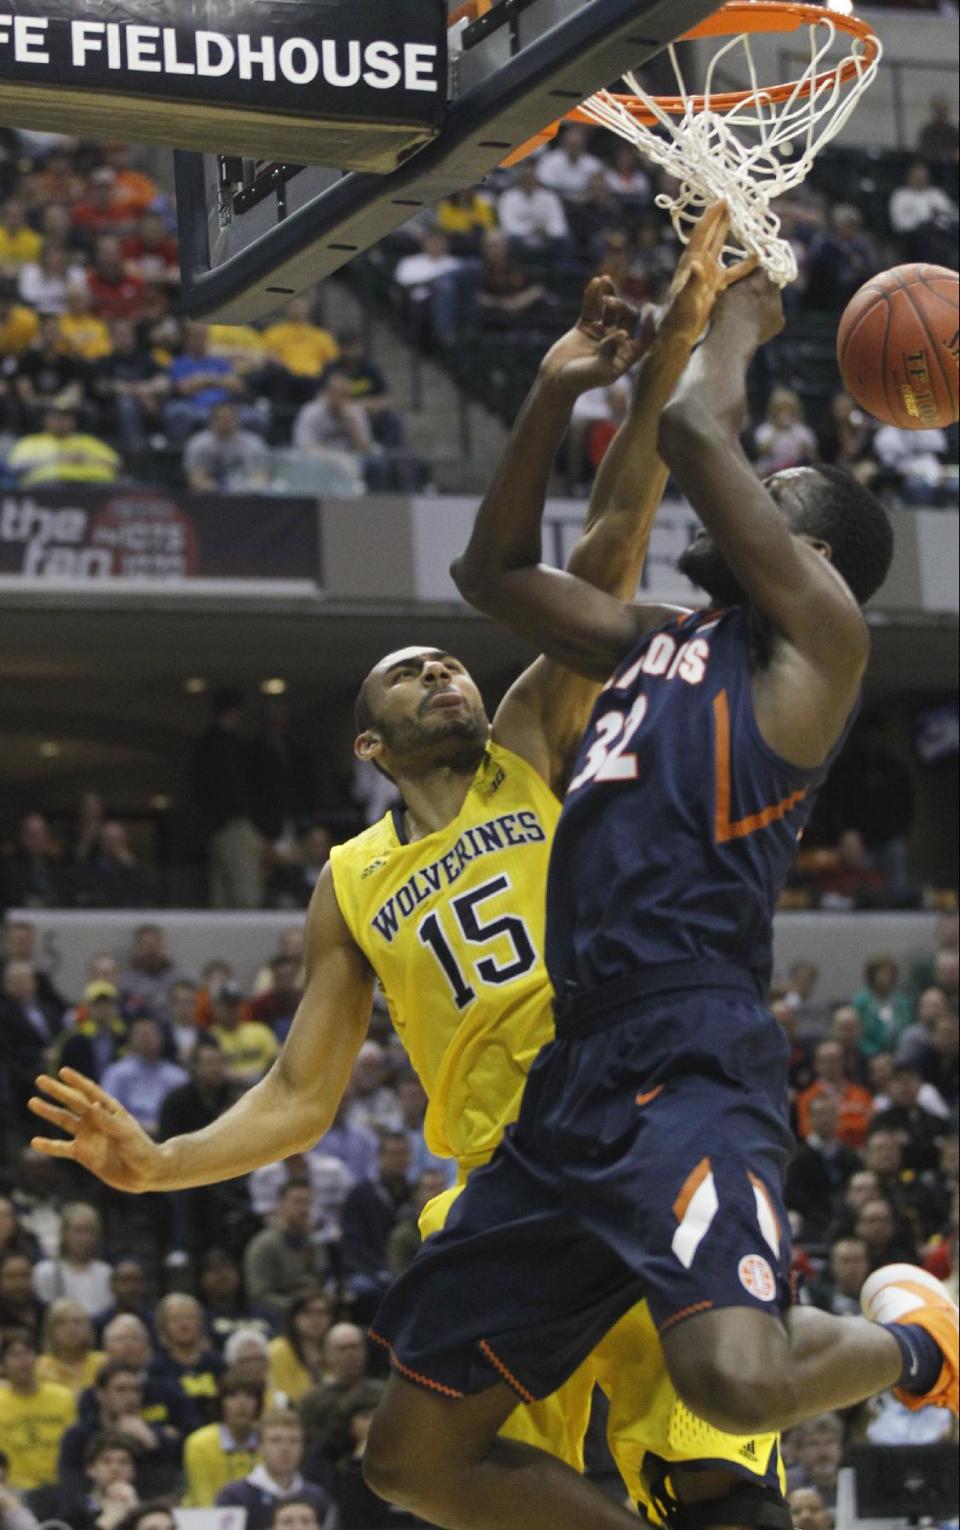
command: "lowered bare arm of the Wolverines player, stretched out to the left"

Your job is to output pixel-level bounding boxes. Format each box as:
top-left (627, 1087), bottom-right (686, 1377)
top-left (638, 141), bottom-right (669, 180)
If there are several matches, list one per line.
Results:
top-left (31, 866), bottom-right (374, 1192)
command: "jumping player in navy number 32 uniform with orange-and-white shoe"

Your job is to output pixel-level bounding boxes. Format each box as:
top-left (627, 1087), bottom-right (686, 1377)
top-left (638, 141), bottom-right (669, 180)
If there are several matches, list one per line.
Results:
top-left (364, 260), bottom-right (957, 1530)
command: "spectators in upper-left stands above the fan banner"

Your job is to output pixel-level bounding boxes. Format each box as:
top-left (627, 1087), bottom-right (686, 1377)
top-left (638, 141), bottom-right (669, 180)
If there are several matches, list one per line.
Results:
top-left (0, 133), bottom-right (427, 493)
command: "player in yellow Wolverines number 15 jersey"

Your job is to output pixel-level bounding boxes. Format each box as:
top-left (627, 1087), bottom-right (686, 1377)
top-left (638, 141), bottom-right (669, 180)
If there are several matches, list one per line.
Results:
top-left (34, 210), bottom-right (776, 1523)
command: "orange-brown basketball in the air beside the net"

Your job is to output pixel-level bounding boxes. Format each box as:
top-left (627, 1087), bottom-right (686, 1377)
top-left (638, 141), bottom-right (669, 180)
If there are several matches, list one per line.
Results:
top-left (836, 265), bottom-right (960, 430)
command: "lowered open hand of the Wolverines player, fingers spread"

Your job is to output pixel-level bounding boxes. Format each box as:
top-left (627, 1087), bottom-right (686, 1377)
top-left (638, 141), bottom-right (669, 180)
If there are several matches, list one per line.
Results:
top-left (29, 1068), bottom-right (162, 1192)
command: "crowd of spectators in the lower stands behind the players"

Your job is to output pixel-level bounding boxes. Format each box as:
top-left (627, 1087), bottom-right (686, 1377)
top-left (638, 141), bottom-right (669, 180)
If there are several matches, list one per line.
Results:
top-left (0, 915), bottom-right (960, 1530)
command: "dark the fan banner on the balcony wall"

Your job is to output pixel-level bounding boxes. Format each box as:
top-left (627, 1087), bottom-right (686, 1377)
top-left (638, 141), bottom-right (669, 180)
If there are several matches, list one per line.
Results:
top-left (0, 488), bottom-right (318, 581)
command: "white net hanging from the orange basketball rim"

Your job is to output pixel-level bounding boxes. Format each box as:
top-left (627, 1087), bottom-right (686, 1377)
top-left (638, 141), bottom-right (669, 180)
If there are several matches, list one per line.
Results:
top-left (582, 14), bottom-right (880, 286)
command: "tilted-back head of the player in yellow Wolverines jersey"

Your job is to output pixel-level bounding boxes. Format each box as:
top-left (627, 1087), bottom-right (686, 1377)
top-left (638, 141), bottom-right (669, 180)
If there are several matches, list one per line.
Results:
top-left (354, 647), bottom-right (490, 779)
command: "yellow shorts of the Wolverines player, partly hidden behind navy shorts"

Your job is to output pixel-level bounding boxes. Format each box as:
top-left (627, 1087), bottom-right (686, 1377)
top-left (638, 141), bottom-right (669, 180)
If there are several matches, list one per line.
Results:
top-left (420, 1183), bottom-right (785, 1524)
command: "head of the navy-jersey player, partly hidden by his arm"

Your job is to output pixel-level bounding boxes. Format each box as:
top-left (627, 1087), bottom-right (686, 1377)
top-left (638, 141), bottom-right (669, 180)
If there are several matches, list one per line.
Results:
top-left (677, 465), bottom-right (893, 606)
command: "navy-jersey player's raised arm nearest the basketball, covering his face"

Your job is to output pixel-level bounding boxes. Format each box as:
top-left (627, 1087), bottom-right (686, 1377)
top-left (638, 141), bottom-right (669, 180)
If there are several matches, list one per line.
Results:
top-left (658, 272), bottom-right (868, 765)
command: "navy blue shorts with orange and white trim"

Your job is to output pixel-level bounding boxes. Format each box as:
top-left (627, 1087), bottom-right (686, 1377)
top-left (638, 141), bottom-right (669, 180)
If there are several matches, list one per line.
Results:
top-left (372, 968), bottom-right (793, 1401)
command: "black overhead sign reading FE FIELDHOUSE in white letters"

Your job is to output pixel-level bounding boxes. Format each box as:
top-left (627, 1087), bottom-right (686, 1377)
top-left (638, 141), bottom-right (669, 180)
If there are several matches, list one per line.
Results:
top-left (0, 0), bottom-right (447, 170)
